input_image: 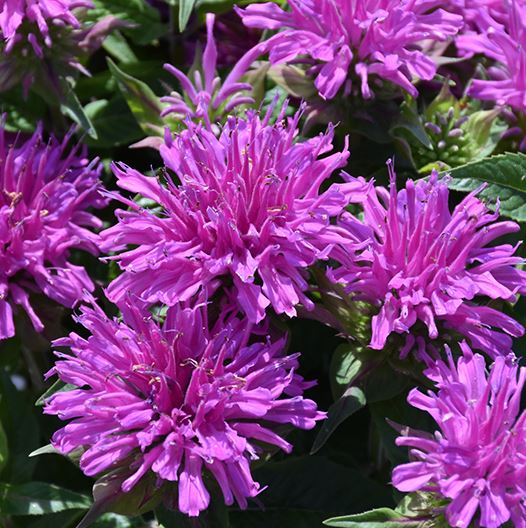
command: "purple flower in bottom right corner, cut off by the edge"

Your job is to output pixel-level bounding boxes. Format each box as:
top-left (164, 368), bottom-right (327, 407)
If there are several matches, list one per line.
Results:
top-left (393, 344), bottom-right (526, 528)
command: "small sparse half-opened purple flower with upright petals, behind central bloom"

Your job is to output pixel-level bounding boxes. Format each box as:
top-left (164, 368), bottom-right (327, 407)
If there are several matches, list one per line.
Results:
top-left (161, 14), bottom-right (261, 129)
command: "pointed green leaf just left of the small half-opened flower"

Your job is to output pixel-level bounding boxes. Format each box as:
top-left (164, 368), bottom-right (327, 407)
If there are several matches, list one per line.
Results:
top-left (108, 58), bottom-right (164, 135)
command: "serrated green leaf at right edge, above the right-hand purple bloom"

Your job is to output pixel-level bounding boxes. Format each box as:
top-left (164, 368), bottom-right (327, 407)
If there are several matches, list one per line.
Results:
top-left (448, 152), bottom-right (526, 222)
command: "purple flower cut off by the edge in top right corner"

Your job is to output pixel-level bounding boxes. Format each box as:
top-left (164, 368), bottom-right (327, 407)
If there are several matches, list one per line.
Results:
top-left (457, 3), bottom-right (526, 112)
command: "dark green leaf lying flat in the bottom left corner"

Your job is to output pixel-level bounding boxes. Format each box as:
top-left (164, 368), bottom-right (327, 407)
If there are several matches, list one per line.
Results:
top-left (0, 482), bottom-right (91, 515)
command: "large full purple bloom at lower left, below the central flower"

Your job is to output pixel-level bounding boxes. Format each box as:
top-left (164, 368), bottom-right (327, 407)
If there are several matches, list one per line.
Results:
top-left (45, 305), bottom-right (325, 516)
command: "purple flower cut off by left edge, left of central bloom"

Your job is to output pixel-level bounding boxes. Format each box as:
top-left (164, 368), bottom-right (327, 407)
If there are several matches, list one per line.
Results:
top-left (0, 122), bottom-right (105, 340)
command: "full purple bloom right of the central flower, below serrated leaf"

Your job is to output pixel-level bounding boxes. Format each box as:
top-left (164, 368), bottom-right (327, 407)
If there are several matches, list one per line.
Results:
top-left (331, 162), bottom-right (526, 357)
